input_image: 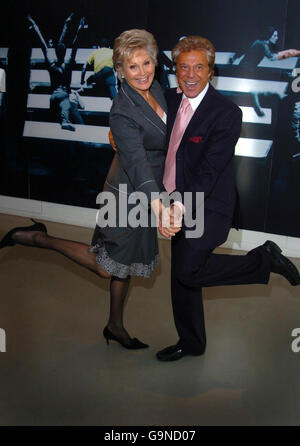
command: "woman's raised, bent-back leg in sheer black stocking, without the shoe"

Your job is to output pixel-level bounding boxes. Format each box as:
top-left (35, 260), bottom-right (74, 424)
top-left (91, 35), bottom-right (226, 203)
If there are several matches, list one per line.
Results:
top-left (12, 231), bottom-right (111, 279)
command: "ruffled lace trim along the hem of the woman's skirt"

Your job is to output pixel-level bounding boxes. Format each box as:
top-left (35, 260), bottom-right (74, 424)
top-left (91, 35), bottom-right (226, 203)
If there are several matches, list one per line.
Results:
top-left (89, 243), bottom-right (159, 279)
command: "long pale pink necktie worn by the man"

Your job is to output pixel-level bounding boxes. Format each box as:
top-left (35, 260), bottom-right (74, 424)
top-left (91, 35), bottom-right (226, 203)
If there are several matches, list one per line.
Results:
top-left (163, 98), bottom-right (194, 194)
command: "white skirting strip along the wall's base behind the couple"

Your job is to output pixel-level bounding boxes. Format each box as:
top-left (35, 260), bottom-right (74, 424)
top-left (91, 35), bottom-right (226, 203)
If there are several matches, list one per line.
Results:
top-left (0, 195), bottom-right (300, 258)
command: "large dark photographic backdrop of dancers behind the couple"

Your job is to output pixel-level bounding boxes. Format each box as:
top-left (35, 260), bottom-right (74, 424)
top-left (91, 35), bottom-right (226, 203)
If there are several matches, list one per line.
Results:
top-left (0, 0), bottom-right (300, 237)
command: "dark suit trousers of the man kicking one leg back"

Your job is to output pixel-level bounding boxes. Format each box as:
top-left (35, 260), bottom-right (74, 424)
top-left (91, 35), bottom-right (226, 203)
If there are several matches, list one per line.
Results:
top-left (171, 214), bottom-right (271, 354)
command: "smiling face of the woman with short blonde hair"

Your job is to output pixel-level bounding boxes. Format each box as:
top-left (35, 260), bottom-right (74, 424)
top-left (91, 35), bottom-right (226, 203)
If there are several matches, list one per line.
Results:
top-left (122, 49), bottom-right (155, 94)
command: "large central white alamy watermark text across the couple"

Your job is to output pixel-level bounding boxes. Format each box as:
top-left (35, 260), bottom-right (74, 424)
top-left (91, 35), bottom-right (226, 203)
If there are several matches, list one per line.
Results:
top-left (96, 184), bottom-right (204, 238)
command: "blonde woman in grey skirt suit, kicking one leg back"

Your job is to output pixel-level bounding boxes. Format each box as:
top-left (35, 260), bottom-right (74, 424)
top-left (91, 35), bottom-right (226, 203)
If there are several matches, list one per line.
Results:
top-left (0, 29), bottom-right (179, 349)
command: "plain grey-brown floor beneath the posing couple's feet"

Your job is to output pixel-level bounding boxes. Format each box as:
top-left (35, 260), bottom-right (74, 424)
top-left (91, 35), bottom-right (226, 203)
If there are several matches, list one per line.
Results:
top-left (0, 214), bottom-right (300, 426)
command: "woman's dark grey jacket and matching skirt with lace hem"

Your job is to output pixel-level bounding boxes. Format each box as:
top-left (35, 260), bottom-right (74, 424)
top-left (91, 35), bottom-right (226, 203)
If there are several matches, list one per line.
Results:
top-left (90, 80), bottom-right (167, 278)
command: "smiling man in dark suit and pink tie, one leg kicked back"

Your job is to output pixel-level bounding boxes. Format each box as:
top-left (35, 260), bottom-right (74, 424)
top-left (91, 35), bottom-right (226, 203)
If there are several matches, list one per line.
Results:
top-left (157, 36), bottom-right (300, 361)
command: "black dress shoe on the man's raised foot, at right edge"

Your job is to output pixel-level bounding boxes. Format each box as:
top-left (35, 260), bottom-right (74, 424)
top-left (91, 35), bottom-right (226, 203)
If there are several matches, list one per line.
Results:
top-left (263, 240), bottom-right (300, 286)
